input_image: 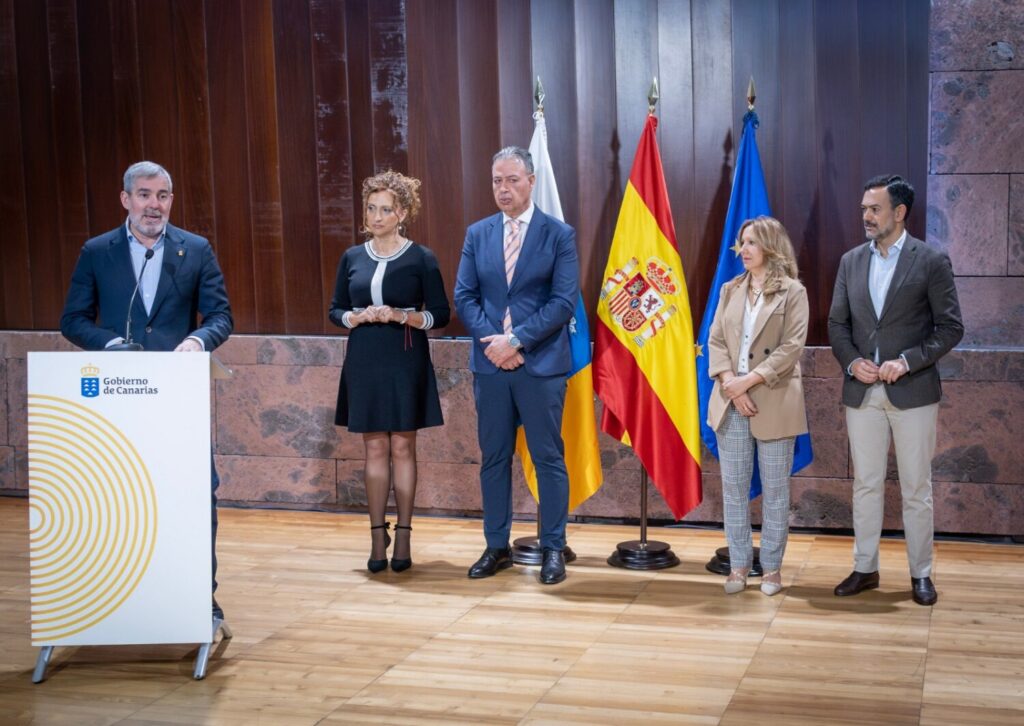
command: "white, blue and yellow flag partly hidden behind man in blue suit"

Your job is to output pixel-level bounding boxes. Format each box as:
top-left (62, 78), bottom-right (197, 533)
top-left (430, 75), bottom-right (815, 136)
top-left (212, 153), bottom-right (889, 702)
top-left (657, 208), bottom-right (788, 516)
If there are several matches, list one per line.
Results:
top-left (515, 112), bottom-right (602, 511)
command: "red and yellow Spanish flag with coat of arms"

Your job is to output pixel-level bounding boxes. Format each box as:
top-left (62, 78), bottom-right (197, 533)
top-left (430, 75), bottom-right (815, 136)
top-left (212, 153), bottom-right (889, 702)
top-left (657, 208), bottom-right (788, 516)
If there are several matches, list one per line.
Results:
top-left (594, 114), bottom-right (701, 519)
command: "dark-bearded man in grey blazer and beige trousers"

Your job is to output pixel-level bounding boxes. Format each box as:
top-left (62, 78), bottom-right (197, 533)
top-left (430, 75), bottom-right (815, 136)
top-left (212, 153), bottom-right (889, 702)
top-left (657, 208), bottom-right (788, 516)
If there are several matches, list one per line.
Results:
top-left (828, 175), bottom-right (964, 605)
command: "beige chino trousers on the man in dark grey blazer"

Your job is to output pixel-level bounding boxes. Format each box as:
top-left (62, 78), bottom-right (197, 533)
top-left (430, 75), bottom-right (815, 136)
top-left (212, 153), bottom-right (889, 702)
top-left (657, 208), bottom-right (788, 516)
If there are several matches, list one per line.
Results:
top-left (846, 383), bottom-right (939, 578)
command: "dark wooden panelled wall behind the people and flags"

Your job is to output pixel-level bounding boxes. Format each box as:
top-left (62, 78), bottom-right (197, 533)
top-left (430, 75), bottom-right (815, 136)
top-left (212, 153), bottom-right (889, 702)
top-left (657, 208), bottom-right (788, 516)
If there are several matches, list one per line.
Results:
top-left (0, 0), bottom-right (929, 343)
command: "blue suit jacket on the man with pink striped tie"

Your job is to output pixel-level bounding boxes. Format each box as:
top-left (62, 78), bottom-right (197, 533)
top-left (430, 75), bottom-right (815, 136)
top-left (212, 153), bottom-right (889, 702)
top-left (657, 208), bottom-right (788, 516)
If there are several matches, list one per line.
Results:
top-left (455, 207), bottom-right (580, 376)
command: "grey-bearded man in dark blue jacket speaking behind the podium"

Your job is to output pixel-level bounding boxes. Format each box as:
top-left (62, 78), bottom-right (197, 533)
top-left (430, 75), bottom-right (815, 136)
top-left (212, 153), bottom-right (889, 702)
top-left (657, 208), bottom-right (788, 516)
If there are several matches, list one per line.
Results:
top-left (60, 162), bottom-right (233, 618)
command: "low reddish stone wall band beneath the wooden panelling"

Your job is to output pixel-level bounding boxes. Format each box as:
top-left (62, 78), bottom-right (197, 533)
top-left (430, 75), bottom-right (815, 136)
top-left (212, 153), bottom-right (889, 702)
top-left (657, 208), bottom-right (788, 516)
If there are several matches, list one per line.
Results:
top-left (0, 333), bottom-right (1024, 535)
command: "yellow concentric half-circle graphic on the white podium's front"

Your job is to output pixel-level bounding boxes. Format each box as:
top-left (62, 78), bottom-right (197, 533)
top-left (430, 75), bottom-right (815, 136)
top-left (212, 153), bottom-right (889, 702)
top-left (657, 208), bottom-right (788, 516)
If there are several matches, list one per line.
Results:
top-left (29, 394), bottom-right (157, 641)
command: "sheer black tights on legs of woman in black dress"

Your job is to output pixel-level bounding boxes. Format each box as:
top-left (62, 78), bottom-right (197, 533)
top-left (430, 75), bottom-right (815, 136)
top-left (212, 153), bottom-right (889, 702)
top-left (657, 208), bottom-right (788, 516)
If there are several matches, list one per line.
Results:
top-left (362, 431), bottom-right (416, 559)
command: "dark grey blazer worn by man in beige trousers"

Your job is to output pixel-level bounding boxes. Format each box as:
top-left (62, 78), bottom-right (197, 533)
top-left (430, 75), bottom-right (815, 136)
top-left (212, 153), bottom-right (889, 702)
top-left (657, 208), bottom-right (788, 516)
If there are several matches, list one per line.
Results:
top-left (828, 234), bottom-right (964, 409)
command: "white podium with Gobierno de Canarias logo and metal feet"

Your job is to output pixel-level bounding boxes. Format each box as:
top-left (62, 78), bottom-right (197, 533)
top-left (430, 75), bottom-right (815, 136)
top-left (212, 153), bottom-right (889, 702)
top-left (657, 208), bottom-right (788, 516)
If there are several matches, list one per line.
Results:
top-left (28, 352), bottom-right (230, 683)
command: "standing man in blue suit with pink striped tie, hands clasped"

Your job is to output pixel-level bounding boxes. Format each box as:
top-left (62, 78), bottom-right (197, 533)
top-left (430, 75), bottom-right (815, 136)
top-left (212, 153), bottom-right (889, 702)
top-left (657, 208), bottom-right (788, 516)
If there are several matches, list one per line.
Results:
top-left (455, 146), bottom-right (580, 585)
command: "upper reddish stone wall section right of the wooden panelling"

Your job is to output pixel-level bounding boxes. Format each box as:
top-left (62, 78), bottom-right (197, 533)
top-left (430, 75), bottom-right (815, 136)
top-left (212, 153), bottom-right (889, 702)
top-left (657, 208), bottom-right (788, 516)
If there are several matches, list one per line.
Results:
top-left (927, 0), bottom-right (1024, 347)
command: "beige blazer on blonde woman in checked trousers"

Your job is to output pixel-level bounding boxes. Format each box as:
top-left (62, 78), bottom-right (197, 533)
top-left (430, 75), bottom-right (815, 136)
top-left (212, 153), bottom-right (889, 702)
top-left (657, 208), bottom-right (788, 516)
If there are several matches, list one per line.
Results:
top-left (707, 273), bottom-right (809, 440)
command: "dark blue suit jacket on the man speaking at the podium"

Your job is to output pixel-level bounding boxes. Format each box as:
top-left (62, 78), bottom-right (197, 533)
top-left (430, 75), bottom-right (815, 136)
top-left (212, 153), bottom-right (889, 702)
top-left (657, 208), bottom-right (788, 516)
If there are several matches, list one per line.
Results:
top-left (60, 224), bottom-right (233, 351)
